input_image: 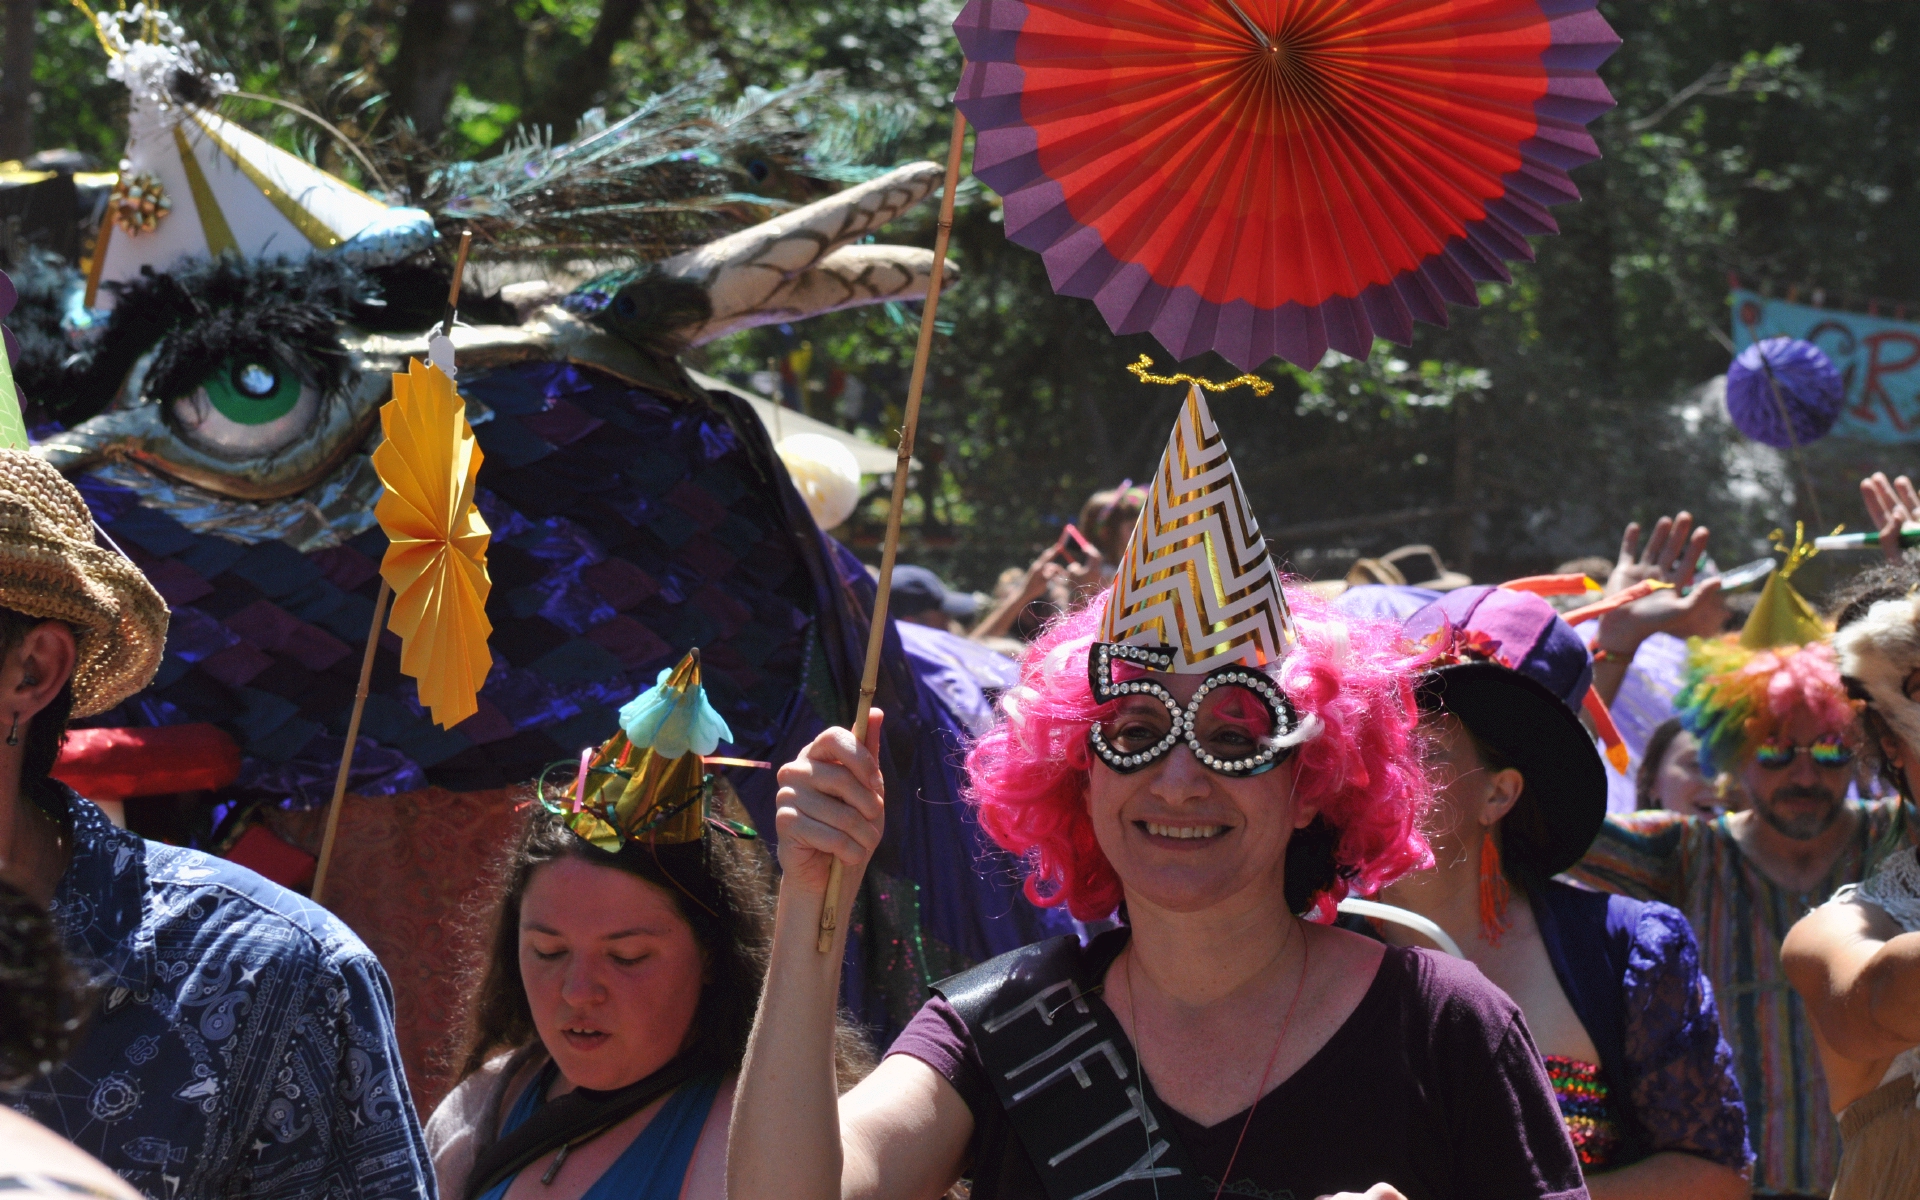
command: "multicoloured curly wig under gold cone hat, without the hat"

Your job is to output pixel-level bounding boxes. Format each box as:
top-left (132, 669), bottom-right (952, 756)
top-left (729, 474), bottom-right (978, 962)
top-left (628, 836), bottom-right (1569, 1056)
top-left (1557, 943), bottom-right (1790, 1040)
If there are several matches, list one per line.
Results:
top-left (1674, 634), bottom-right (1857, 780)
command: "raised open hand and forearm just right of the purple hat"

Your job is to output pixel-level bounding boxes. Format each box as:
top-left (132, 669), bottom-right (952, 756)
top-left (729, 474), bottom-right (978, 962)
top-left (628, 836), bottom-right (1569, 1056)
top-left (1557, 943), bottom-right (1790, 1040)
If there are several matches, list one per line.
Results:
top-left (1594, 513), bottom-right (1726, 705)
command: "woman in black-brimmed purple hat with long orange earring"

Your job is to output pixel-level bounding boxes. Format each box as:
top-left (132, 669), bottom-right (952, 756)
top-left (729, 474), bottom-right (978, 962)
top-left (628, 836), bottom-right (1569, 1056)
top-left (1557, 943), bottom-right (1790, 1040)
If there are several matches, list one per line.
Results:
top-left (1382, 588), bottom-right (1749, 1200)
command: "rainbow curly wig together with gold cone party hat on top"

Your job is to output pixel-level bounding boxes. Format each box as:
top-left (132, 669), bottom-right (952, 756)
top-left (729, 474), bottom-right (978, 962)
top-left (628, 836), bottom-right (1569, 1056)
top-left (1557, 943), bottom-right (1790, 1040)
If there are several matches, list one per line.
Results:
top-left (1674, 532), bottom-right (1855, 780)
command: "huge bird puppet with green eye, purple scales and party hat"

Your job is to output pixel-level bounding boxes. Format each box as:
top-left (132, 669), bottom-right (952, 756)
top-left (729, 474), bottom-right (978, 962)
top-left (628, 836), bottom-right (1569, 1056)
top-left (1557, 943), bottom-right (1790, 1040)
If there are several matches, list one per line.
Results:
top-left (13, 4), bottom-right (1050, 1104)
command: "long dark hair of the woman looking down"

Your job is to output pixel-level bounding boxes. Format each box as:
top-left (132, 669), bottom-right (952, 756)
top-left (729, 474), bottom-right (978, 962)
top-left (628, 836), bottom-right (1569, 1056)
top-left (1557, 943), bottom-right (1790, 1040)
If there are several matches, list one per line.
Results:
top-left (459, 789), bottom-right (872, 1089)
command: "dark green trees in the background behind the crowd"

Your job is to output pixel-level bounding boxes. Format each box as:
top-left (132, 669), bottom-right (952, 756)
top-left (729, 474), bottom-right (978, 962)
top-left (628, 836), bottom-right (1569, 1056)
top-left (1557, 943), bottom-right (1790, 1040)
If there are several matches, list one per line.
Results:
top-left (22, 0), bottom-right (1920, 588)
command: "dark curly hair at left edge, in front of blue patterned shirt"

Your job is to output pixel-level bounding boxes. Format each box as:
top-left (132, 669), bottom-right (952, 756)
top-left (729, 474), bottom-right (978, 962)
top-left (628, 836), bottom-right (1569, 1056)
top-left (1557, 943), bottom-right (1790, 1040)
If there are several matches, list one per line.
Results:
top-left (0, 871), bottom-right (81, 1089)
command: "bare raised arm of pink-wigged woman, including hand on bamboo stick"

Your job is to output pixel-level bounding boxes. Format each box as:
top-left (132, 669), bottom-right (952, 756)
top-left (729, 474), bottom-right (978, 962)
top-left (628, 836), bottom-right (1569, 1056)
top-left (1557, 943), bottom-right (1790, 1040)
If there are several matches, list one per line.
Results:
top-left (728, 708), bottom-right (973, 1200)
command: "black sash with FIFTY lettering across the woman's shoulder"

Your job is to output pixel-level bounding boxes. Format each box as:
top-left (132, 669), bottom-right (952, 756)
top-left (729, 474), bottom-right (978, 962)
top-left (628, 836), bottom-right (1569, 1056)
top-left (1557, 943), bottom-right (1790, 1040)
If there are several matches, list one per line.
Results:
top-left (933, 931), bottom-right (1204, 1200)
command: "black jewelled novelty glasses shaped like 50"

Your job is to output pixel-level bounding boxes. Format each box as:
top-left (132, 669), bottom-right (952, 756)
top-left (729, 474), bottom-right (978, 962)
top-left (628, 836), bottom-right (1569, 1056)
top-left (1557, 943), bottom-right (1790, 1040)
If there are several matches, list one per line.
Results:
top-left (1087, 641), bottom-right (1319, 778)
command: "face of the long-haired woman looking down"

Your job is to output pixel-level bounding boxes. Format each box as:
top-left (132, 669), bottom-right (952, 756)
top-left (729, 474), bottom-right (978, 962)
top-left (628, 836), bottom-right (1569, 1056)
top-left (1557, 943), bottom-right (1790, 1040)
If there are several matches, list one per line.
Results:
top-left (520, 858), bottom-right (707, 1091)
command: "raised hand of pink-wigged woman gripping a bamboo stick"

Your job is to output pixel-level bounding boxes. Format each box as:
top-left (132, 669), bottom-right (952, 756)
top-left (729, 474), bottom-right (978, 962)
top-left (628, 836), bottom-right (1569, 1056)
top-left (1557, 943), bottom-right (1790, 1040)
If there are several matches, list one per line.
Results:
top-left (774, 708), bottom-right (887, 895)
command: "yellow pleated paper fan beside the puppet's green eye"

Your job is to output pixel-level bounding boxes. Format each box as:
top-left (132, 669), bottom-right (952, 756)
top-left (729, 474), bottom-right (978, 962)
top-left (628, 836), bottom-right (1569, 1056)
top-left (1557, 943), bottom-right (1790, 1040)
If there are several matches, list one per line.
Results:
top-left (372, 359), bottom-right (493, 728)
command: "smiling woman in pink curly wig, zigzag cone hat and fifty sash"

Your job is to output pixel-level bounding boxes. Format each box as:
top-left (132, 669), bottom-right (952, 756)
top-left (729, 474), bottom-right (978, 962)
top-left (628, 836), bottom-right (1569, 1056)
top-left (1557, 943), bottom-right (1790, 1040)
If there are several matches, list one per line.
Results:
top-left (728, 390), bottom-right (1586, 1200)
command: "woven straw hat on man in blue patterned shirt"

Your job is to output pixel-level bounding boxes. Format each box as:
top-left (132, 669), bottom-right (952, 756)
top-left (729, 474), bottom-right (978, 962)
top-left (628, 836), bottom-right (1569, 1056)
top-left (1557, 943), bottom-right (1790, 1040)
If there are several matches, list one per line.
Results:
top-left (0, 449), bottom-right (167, 716)
